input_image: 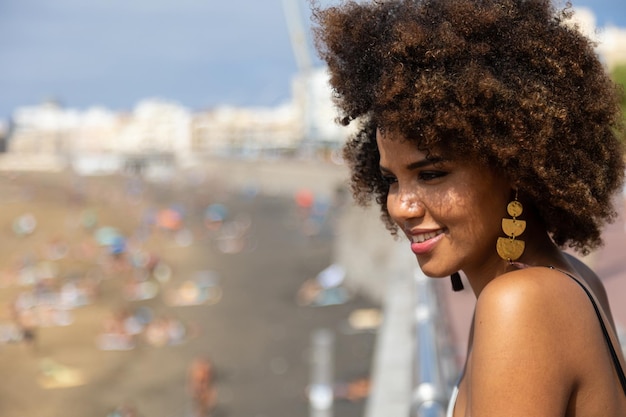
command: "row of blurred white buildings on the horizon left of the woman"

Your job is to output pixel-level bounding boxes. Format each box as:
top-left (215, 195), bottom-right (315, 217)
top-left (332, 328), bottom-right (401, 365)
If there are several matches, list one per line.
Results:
top-left (3, 69), bottom-right (348, 170)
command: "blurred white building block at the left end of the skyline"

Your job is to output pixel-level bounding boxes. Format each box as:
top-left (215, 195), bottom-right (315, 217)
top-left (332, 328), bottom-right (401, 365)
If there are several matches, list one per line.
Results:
top-left (7, 100), bottom-right (191, 172)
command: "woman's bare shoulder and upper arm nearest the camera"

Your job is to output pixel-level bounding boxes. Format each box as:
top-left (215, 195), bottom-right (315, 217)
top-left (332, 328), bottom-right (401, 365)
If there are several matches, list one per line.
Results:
top-left (471, 268), bottom-right (593, 416)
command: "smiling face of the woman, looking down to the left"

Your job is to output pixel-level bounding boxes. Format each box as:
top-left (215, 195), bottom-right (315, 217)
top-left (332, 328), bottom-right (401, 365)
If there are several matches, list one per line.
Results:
top-left (376, 132), bottom-right (511, 277)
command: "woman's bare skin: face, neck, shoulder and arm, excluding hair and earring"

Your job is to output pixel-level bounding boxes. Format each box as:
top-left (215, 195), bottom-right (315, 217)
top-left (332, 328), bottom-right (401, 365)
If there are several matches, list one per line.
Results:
top-left (376, 131), bottom-right (626, 417)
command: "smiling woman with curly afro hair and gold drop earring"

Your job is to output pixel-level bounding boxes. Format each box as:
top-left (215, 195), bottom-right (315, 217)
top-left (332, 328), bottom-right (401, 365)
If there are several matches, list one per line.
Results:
top-left (314, 0), bottom-right (626, 417)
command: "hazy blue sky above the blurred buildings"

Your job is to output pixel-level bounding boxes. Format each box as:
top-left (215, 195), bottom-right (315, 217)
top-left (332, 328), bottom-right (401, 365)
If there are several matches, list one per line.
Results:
top-left (0, 0), bottom-right (626, 121)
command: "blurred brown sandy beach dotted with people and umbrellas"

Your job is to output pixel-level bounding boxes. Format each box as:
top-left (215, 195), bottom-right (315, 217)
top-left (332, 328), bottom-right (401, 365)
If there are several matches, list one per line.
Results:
top-left (0, 167), bottom-right (376, 417)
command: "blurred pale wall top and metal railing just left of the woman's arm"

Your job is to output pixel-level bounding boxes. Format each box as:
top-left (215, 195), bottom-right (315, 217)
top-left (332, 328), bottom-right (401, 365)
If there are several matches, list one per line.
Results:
top-left (365, 269), bottom-right (458, 417)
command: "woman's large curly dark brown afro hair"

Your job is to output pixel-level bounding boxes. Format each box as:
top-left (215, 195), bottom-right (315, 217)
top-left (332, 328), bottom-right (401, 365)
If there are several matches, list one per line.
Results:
top-left (312, 0), bottom-right (624, 253)
